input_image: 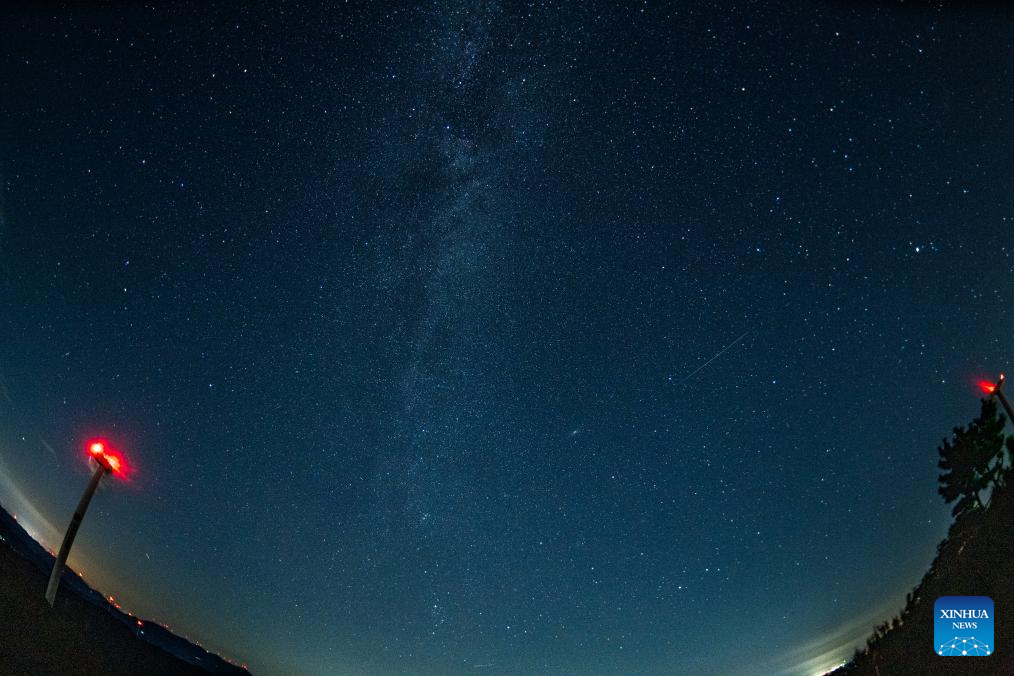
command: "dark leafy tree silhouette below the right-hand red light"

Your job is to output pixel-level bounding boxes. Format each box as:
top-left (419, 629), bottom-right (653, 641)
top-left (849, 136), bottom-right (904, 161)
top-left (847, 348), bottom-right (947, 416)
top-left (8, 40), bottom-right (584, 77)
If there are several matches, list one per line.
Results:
top-left (937, 398), bottom-right (1006, 516)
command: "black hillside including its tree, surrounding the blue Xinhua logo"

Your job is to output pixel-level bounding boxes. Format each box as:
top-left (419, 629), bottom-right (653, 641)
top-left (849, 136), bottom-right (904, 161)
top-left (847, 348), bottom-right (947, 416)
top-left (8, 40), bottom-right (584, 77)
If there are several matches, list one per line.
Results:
top-left (831, 399), bottom-right (1014, 676)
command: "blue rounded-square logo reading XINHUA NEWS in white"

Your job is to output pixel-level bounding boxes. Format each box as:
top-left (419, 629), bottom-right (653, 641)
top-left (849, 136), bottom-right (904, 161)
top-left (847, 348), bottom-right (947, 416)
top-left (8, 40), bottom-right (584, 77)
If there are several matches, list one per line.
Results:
top-left (933, 596), bottom-right (996, 657)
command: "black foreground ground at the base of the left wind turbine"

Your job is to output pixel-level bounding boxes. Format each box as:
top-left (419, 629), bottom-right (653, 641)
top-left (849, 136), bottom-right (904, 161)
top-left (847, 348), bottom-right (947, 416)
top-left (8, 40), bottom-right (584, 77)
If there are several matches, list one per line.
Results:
top-left (0, 546), bottom-right (208, 676)
